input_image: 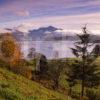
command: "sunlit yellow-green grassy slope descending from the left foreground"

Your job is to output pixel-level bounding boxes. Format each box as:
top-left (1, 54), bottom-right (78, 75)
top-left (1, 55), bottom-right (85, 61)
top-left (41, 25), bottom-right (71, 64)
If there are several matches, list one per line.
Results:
top-left (0, 68), bottom-right (67, 100)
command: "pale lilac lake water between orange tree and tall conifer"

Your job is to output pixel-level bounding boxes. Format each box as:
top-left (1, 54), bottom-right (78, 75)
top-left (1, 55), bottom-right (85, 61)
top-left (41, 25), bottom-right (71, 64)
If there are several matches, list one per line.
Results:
top-left (20, 41), bottom-right (75, 59)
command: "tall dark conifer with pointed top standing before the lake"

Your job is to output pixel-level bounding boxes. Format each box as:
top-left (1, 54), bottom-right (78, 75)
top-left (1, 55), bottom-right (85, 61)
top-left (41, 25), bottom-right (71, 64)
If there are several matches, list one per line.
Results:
top-left (69, 26), bottom-right (100, 97)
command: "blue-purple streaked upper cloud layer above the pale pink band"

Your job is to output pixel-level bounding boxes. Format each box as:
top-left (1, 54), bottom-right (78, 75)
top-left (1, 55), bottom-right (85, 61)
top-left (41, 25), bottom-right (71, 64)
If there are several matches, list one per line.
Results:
top-left (0, 0), bottom-right (100, 21)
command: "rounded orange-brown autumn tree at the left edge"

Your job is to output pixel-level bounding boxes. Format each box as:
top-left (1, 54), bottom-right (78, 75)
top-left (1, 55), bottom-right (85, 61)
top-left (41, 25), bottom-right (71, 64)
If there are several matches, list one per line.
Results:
top-left (0, 33), bottom-right (21, 67)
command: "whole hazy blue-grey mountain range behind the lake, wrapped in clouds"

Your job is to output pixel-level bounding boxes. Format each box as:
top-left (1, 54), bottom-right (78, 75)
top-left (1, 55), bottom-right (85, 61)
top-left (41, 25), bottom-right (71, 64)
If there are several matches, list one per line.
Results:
top-left (6, 25), bottom-right (100, 43)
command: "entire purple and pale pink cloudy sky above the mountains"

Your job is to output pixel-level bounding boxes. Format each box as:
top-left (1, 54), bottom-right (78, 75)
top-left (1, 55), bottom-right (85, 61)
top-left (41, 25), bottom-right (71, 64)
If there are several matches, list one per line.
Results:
top-left (0, 0), bottom-right (100, 34)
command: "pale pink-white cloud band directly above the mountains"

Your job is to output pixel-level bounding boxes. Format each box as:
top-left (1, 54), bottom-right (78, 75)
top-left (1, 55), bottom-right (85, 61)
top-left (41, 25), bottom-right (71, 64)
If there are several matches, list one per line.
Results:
top-left (0, 13), bottom-right (100, 34)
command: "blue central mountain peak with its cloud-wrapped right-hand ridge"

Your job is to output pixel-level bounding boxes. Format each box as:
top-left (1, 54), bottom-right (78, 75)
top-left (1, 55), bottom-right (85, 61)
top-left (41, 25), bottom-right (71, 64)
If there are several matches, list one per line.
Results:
top-left (28, 26), bottom-right (77, 41)
